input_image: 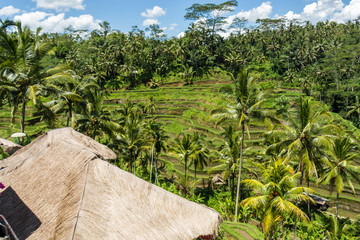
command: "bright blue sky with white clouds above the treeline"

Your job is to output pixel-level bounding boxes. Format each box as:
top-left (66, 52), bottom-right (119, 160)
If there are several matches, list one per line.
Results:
top-left (0, 0), bottom-right (360, 37)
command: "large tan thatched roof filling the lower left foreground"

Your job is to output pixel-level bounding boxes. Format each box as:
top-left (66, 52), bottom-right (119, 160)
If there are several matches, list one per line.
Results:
top-left (0, 128), bottom-right (221, 240)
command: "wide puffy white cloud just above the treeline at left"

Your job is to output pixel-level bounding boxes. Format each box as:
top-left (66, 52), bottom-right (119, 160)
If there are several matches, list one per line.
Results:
top-left (14, 11), bottom-right (101, 32)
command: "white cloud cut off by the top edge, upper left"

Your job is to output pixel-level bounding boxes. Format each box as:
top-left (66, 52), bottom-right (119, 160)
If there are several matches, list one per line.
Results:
top-left (33, 0), bottom-right (85, 10)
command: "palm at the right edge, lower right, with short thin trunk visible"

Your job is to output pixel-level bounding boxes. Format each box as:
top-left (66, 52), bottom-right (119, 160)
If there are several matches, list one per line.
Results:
top-left (318, 137), bottom-right (360, 218)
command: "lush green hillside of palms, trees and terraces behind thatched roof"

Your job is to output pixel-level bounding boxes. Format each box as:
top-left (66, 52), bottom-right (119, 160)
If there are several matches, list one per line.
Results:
top-left (0, 1), bottom-right (360, 239)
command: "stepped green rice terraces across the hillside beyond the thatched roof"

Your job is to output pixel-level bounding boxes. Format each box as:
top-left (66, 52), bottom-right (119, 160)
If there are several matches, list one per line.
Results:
top-left (0, 74), bottom-right (360, 217)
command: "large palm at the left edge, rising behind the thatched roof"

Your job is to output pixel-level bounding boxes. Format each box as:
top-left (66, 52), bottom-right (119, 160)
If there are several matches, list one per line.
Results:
top-left (0, 22), bottom-right (52, 132)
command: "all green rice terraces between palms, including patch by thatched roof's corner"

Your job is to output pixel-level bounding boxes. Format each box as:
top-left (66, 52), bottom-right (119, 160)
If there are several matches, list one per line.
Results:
top-left (0, 74), bottom-right (360, 239)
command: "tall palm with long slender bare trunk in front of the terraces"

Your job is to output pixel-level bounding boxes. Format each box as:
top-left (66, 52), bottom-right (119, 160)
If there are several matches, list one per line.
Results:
top-left (212, 71), bottom-right (265, 221)
